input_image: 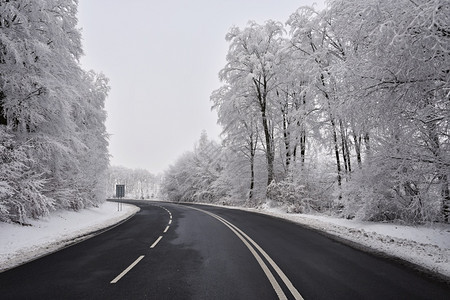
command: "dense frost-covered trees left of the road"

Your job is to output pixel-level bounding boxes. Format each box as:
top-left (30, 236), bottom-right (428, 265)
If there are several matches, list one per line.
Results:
top-left (0, 0), bottom-right (109, 224)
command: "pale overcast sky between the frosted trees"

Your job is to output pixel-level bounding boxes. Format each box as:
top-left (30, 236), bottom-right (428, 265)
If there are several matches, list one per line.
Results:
top-left (78, 0), bottom-right (324, 174)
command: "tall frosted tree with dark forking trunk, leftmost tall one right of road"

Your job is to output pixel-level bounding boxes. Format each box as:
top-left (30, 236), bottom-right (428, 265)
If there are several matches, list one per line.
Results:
top-left (220, 21), bottom-right (284, 189)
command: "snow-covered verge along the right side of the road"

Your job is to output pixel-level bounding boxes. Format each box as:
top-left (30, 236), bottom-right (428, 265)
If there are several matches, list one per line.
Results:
top-left (250, 206), bottom-right (450, 280)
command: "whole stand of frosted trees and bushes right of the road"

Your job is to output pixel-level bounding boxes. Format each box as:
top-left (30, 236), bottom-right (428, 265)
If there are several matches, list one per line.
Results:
top-left (162, 0), bottom-right (450, 224)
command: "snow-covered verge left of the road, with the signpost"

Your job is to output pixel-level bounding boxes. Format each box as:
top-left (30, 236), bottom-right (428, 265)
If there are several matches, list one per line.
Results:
top-left (0, 202), bottom-right (139, 272)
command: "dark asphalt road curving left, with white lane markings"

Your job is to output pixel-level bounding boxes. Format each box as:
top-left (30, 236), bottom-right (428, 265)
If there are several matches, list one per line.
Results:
top-left (0, 201), bottom-right (450, 300)
